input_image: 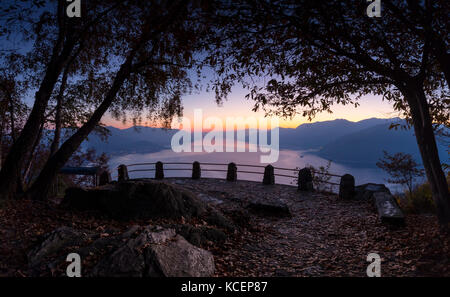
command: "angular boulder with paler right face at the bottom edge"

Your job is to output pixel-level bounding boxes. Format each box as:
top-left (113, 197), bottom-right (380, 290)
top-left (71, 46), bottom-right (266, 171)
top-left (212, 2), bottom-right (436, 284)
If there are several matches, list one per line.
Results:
top-left (91, 227), bottom-right (214, 277)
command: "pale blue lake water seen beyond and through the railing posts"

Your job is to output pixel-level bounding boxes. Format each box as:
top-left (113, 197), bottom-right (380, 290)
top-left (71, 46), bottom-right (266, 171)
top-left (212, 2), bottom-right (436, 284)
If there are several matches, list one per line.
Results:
top-left (109, 150), bottom-right (408, 191)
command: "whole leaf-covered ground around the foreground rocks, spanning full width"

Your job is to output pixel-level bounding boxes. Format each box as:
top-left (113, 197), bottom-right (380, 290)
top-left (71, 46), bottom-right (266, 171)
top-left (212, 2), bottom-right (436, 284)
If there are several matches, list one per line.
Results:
top-left (0, 179), bottom-right (450, 277)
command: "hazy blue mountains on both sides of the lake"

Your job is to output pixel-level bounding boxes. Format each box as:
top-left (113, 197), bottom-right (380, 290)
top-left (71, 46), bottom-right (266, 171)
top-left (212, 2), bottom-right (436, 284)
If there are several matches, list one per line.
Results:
top-left (83, 118), bottom-right (449, 167)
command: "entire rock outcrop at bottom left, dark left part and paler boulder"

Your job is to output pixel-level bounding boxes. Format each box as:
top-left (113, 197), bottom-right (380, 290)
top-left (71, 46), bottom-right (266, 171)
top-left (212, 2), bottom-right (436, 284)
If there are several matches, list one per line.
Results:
top-left (29, 226), bottom-right (215, 277)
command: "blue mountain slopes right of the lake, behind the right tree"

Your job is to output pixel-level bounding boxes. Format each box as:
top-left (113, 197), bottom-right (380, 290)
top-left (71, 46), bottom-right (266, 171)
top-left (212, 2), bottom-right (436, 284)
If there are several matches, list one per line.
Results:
top-left (280, 118), bottom-right (449, 167)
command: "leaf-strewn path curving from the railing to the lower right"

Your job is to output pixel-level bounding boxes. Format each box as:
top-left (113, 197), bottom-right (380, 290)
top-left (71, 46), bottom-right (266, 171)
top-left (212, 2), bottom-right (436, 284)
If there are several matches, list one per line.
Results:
top-left (166, 179), bottom-right (450, 277)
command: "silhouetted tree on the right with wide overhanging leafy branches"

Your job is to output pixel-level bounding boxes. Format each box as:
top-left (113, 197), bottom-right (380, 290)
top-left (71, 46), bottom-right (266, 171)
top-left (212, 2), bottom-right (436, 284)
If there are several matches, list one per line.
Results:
top-left (209, 0), bottom-right (450, 226)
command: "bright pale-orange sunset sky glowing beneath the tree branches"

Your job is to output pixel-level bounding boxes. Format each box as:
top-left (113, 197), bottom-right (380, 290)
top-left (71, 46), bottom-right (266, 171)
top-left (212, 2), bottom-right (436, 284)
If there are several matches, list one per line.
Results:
top-left (102, 87), bottom-right (398, 129)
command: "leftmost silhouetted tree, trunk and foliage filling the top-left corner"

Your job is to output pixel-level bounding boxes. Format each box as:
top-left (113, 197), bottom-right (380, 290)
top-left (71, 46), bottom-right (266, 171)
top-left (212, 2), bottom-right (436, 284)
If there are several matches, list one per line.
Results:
top-left (0, 0), bottom-right (126, 199)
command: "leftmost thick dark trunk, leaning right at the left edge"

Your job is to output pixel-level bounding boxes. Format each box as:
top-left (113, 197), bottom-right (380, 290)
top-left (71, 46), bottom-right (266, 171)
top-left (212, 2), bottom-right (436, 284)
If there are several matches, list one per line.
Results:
top-left (0, 35), bottom-right (74, 200)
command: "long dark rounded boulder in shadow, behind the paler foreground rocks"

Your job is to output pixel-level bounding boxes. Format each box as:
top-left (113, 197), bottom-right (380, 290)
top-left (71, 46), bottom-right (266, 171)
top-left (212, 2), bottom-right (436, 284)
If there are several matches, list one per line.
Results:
top-left (63, 180), bottom-right (206, 219)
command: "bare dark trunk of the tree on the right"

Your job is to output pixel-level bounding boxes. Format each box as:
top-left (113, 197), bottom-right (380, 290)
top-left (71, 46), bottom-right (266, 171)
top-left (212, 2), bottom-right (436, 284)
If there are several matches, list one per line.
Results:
top-left (403, 80), bottom-right (450, 230)
